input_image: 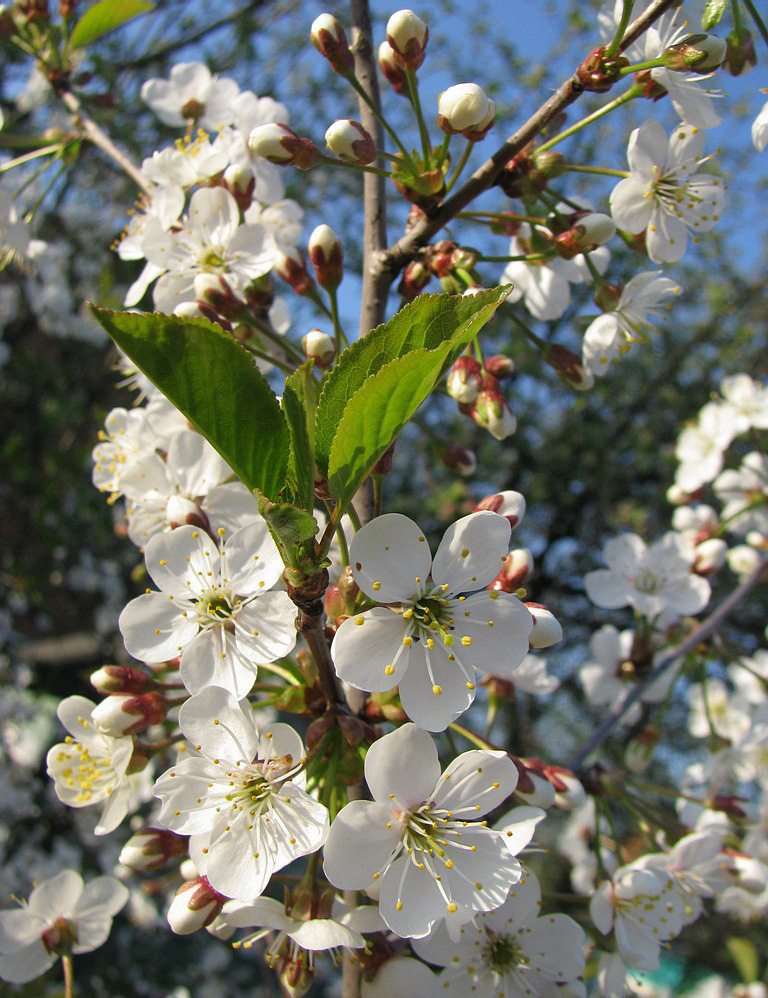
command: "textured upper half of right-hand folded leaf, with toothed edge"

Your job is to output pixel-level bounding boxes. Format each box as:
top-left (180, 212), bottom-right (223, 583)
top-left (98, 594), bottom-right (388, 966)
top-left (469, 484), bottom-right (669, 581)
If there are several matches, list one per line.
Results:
top-left (315, 286), bottom-right (510, 474)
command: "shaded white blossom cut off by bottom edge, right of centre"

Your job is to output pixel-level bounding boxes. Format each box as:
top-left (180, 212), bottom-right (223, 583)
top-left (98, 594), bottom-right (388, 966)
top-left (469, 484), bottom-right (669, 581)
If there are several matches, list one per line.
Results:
top-left (412, 869), bottom-right (586, 998)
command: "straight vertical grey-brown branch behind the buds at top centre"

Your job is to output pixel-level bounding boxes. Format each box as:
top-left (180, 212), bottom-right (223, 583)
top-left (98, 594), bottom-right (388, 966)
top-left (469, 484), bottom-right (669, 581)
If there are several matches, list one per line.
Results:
top-left (350, 0), bottom-right (391, 336)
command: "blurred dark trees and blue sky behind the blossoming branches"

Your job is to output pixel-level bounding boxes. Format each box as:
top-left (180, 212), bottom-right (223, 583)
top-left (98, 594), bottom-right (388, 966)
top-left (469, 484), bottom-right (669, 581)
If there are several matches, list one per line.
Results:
top-left (0, 0), bottom-right (768, 998)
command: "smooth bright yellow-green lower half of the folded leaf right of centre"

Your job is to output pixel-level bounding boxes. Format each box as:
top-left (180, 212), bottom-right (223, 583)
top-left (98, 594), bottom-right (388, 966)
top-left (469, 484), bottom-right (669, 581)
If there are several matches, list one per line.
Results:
top-left (328, 346), bottom-right (449, 507)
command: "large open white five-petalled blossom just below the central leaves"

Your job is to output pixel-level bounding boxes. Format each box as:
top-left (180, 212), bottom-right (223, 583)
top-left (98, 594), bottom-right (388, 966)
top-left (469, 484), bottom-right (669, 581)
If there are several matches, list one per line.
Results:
top-left (331, 511), bottom-right (533, 731)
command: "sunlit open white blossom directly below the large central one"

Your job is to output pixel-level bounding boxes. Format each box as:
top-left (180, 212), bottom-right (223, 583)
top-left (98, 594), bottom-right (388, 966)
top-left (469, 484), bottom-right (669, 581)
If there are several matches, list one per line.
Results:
top-left (324, 724), bottom-right (521, 937)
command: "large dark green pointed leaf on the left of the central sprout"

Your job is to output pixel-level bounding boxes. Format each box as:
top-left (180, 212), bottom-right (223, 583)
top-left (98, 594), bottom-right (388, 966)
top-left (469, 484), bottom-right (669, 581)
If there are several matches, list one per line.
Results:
top-left (91, 305), bottom-right (289, 499)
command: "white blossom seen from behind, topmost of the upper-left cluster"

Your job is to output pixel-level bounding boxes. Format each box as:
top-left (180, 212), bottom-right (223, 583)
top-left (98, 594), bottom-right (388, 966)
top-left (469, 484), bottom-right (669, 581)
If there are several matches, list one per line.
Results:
top-left (141, 62), bottom-right (240, 131)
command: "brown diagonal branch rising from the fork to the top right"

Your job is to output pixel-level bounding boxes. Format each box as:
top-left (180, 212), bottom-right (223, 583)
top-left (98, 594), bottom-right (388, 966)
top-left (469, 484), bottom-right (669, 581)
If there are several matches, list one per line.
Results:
top-left (374, 0), bottom-right (675, 284)
